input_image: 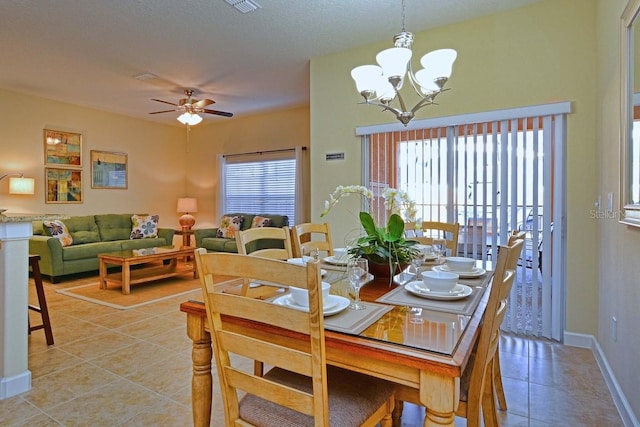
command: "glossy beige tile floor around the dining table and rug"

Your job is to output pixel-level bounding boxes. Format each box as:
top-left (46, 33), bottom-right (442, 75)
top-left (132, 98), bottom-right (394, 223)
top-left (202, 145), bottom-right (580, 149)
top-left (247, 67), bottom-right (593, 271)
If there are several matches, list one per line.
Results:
top-left (0, 276), bottom-right (622, 427)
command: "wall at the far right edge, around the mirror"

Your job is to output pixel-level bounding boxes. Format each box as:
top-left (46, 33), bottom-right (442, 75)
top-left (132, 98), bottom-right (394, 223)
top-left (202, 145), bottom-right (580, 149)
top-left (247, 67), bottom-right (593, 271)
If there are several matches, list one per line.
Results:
top-left (597, 0), bottom-right (640, 417)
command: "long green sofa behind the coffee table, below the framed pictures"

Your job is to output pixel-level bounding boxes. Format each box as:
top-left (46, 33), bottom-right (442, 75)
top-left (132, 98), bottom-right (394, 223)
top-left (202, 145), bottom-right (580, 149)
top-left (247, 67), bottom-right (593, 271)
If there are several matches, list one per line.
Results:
top-left (29, 214), bottom-right (174, 283)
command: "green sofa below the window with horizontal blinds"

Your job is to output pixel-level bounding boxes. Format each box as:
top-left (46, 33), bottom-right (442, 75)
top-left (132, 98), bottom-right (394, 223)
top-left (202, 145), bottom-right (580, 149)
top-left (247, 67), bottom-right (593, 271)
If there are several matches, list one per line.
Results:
top-left (193, 213), bottom-right (289, 253)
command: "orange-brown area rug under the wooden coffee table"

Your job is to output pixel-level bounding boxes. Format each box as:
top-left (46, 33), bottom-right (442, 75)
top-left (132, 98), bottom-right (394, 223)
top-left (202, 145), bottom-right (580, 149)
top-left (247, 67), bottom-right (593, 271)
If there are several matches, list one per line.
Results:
top-left (56, 276), bottom-right (200, 310)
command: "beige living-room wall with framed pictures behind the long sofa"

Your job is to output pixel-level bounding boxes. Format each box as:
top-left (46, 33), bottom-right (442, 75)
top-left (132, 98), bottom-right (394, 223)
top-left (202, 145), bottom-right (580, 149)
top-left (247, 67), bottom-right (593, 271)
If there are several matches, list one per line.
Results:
top-left (0, 90), bottom-right (186, 228)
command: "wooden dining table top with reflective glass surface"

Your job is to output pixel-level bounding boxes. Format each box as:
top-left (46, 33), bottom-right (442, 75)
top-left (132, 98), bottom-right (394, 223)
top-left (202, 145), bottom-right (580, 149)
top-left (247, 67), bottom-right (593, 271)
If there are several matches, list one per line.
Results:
top-left (180, 266), bottom-right (490, 377)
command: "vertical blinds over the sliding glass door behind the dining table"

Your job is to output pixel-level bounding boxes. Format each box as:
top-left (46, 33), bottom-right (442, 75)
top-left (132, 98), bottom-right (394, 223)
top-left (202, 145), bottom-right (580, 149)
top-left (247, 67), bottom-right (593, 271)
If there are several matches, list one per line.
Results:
top-left (357, 103), bottom-right (569, 339)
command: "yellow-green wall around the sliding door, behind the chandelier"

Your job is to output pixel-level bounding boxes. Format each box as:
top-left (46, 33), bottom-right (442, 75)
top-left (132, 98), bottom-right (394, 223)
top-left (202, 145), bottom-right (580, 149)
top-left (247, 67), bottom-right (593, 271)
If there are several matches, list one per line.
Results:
top-left (311, 0), bottom-right (598, 334)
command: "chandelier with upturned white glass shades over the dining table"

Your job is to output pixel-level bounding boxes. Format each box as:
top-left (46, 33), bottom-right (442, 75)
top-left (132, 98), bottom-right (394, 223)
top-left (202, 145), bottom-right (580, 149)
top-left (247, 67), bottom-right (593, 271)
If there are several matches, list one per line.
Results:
top-left (351, 0), bottom-right (457, 126)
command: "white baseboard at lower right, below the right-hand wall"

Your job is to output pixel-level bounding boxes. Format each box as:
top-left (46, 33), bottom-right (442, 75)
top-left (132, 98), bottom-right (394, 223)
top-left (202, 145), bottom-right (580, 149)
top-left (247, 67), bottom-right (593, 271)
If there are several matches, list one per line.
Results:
top-left (564, 331), bottom-right (640, 427)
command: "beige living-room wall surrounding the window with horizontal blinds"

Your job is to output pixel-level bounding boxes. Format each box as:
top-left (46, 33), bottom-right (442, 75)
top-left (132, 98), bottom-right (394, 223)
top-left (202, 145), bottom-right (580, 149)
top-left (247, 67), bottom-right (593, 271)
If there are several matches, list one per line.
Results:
top-left (187, 106), bottom-right (309, 228)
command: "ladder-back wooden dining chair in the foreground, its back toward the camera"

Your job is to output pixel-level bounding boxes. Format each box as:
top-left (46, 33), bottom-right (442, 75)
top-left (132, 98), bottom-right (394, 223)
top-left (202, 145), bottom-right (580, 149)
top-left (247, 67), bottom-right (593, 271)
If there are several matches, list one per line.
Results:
top-left (195, 248), bottom-right (395, 427)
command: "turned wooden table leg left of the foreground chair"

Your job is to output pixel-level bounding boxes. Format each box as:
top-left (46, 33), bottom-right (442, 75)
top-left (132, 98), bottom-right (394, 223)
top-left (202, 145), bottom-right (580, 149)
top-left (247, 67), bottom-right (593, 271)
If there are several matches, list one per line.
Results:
top-left (187, 313), bottom-right (213, 427)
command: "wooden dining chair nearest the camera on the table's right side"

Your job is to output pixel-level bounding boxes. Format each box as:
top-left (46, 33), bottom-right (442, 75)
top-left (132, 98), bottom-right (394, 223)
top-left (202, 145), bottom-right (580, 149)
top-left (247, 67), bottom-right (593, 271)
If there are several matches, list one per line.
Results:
top-left (396, 240), bottom-right (524, 427)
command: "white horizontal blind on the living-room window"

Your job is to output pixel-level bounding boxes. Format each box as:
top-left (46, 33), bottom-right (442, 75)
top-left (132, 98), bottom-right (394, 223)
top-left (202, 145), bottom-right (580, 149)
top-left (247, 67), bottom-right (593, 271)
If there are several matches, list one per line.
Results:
top-left (224, 156), bottom-right (296, 224)
